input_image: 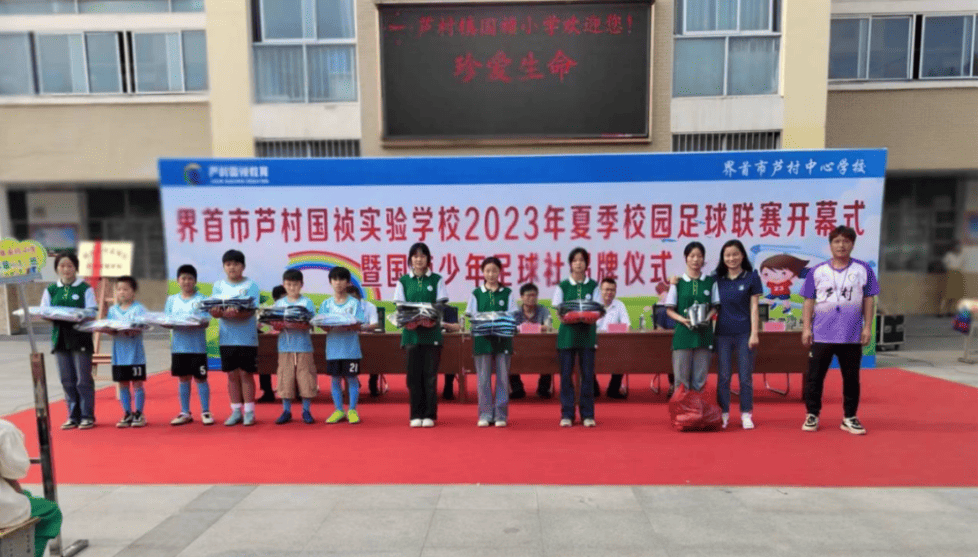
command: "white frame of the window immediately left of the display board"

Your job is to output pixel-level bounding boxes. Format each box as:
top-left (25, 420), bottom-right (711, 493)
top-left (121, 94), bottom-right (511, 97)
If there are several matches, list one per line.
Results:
top-left (251, 0), bottom-right (356, 104)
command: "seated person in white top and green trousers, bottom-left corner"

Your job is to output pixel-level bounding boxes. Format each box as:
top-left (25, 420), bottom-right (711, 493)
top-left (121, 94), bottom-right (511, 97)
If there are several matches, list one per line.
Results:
top-left (0, 420), bottom-right (61, 557)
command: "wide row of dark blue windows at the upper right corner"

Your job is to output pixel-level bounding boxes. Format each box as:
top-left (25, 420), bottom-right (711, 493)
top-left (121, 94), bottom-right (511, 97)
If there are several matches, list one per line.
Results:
top-left (829, 14), bottom-right (978, 80)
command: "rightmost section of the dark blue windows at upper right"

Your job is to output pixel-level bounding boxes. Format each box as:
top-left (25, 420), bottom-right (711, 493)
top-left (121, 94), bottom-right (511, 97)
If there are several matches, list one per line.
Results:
top-left (920, 15), bottom-right (978, 79)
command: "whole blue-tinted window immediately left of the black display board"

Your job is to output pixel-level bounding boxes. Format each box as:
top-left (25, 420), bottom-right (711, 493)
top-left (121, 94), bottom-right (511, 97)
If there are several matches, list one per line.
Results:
top-left (253, 0), bottom-right (357, 102)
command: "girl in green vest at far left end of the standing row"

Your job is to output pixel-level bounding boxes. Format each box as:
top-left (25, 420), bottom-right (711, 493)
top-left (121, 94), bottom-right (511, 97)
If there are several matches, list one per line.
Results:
top-left (41, 253), bottom-right (98, 429)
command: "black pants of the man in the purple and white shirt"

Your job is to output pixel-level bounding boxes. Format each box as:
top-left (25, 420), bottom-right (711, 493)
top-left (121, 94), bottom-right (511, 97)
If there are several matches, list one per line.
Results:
top-left (802, 342), bottom-right (863, 418)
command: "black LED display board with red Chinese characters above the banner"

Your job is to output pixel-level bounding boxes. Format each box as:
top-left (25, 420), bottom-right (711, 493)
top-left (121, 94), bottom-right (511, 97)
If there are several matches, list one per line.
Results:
top-left (378, 0), bottom-right (651, 141)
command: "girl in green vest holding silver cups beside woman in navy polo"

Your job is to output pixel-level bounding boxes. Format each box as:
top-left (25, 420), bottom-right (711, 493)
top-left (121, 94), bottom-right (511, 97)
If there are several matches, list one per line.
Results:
top-left (665, 242), bottom-right (719, 391)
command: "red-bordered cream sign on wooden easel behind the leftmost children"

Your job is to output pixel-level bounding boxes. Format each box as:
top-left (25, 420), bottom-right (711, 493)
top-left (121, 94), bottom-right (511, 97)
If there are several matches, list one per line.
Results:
top-left (78, 240), bottom-right (132, 378)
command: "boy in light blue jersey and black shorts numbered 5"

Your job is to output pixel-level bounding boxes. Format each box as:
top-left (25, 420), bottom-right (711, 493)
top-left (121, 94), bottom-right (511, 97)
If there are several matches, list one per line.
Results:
top-left (163, 265), bottom-right (214, 425)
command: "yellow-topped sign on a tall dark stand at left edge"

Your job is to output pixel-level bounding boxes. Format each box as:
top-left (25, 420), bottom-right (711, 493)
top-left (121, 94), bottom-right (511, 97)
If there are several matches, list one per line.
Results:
top-left (0, 238), bottom-right (88, 557)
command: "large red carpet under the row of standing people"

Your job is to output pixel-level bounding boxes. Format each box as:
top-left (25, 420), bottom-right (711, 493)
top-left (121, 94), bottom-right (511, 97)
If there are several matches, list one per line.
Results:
top-left (8, 369), bottom-right (978, 486)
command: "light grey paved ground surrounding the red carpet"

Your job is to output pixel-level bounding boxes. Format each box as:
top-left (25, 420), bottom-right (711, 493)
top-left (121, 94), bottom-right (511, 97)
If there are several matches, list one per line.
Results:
top-left (0, 318), bottom-right (978, 557)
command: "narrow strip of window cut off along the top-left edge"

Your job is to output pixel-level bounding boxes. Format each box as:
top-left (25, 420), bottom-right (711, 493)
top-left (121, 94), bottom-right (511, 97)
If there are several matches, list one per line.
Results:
top-left (0, 0), bottom-right (204, 15)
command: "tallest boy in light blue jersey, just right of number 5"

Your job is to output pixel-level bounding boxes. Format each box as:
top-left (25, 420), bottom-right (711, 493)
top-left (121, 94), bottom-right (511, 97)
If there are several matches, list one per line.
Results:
top-left (211, 249), bottom-right (261, 426)
